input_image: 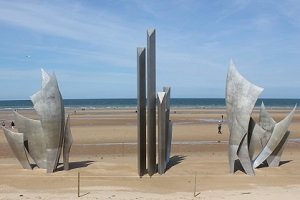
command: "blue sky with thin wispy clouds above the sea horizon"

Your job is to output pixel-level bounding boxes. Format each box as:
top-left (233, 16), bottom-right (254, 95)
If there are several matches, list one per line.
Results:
top-left (0, 0), bottom-right (300, 99)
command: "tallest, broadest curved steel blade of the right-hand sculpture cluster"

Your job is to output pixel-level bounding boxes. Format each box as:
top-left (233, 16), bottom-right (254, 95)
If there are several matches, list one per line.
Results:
top-left (226, 61), bottom-right (263, 175)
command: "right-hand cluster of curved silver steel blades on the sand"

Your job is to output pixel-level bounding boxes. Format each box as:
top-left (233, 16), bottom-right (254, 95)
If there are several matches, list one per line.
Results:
top-left (226, 61), bottom-right (296, 175)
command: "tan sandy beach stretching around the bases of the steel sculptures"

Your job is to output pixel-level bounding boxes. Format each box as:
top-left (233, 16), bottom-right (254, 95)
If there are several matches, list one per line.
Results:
top-left (0, 109), bottom-right (300, 199)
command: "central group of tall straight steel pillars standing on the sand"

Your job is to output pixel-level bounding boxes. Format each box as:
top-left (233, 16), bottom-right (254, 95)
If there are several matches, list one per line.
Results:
top-left (137, 29), bottom-right (172, 177)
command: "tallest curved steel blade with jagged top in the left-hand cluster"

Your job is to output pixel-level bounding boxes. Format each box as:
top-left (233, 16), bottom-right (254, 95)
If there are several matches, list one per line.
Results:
top-left (31, 69), bottom-right (65, 172)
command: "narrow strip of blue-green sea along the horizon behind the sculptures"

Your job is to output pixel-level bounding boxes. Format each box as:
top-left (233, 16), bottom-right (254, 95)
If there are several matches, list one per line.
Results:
top-left (0, 98), bottom-right (300, 110)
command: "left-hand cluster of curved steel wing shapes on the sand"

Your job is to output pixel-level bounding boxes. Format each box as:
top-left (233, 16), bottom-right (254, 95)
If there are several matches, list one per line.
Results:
top-left (4, 69), bottom-right (72, 173)
